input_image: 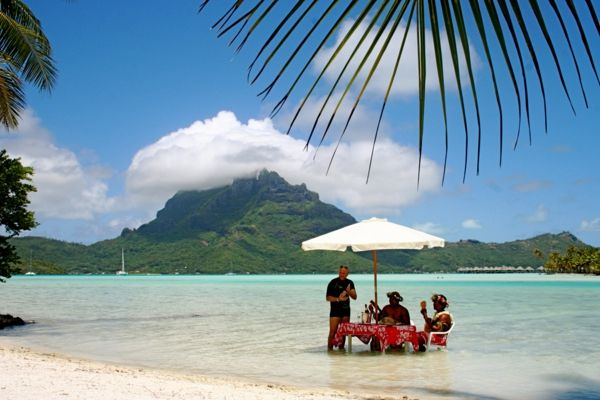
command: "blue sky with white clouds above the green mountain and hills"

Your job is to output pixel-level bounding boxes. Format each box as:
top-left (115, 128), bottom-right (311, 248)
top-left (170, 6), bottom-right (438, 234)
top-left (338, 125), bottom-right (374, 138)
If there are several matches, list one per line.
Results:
top-left (0, 0), bottom-right (600, 246)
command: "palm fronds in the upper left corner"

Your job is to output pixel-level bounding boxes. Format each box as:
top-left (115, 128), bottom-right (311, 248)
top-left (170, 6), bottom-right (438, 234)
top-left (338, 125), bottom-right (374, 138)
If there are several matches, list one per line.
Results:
top-left (0, 0), bottom-right (56, 129)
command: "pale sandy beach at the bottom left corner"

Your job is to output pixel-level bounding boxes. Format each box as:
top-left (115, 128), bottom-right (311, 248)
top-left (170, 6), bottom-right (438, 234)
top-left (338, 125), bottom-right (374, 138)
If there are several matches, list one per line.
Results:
top-left (0, 340), bottom-right (408, 400)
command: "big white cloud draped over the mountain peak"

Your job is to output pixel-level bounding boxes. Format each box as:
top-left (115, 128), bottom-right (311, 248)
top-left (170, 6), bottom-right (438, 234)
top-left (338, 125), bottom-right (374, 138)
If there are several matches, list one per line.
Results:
top-left (126, 111), bottom-right (441, 215)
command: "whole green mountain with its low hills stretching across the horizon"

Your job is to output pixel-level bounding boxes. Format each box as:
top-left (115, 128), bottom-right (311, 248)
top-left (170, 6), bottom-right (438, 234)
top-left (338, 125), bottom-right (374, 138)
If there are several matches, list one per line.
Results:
top-left (13, 171), bottom-right (585, 274)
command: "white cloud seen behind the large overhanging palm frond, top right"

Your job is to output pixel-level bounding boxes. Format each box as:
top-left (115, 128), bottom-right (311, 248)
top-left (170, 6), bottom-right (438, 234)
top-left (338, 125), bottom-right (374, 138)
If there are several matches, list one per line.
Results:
top-left (315, 20), bottom-right (480, 95)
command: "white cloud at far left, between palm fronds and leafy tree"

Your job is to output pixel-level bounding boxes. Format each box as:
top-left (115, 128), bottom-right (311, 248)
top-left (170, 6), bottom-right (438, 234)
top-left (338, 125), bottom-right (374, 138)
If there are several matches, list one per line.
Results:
top-left (0, 110), bottom-right (114, 219)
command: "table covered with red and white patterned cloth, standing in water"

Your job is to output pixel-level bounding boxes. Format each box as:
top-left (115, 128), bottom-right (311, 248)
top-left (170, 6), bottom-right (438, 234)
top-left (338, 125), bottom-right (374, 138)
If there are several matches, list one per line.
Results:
top-left (333, 322), bottom-right (419, 351)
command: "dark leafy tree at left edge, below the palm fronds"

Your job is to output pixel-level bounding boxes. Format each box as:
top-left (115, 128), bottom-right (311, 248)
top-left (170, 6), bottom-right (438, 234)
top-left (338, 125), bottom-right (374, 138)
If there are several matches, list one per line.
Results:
top-left (0, 150), bottom-right (37, 282)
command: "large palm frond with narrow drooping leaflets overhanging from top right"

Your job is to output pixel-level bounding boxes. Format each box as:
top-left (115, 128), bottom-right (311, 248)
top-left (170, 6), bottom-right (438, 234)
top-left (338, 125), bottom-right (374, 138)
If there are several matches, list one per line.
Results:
top-left (200, 0), bottom-right (600, 182)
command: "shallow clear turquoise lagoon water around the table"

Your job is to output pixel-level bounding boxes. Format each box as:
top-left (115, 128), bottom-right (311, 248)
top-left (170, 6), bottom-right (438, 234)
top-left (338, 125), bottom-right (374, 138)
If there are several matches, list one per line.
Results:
top-left (0, 274), bottom-right (600, 400)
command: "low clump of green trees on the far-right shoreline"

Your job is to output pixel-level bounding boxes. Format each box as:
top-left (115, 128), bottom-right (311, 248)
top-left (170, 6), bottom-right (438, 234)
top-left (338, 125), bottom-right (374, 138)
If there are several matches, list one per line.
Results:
top-left (544, 246), bottom-right (600, 275)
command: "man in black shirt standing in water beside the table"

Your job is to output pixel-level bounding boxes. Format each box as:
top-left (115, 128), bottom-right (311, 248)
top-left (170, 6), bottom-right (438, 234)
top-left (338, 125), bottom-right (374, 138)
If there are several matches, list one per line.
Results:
top-left (325, 265), bottom-right (356, 350)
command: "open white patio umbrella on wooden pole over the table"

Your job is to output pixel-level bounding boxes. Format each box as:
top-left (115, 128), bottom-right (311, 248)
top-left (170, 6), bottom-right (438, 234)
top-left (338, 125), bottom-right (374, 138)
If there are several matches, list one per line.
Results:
top-left (302, 218), bottom-right (444, 318)
